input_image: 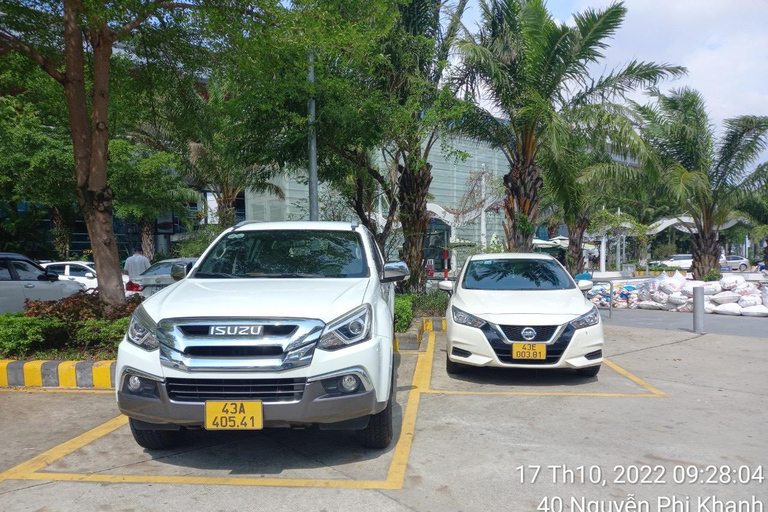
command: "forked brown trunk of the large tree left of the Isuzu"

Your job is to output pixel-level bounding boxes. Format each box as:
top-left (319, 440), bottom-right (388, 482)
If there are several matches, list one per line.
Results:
top-left (64, 0), bottom-right (125, 308)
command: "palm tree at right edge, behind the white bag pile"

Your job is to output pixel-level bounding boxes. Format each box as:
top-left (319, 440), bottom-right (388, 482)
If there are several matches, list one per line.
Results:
top-left (636, 88), bottom-right (768, 279)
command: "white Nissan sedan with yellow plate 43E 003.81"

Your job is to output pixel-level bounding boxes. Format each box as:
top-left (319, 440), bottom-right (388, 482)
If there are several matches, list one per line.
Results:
top-left (439, 253), bottom-right (603, 377)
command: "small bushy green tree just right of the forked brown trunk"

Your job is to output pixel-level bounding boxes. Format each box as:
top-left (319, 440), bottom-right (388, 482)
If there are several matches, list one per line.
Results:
top-left (109, 139), bottom-right (200, 260)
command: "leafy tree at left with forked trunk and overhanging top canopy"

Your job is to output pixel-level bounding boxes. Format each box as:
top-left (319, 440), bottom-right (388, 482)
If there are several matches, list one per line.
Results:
top-left (0, 0), bottom-right (272, 307)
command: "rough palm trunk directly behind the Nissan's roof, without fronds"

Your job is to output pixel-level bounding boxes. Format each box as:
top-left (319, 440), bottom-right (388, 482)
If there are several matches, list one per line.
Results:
top-left (504, 163), bottom-right (544, 252)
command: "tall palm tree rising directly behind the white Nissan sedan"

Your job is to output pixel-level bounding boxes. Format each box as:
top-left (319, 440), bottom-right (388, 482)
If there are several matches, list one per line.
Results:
top-left (454, 0), bottom-right (685, 251)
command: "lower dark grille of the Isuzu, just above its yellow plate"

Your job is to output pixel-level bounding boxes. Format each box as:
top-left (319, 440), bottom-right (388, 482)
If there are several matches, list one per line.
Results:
top-left (166, 378), bottom-right (307, 402)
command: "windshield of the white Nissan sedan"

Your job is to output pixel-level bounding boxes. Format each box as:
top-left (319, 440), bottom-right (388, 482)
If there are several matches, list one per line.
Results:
top-left (462, 259), bottom-right (574, 290)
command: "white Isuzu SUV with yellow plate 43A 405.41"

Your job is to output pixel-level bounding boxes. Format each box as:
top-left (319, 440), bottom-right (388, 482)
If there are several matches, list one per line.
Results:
top-left (115, 222), bottom-right (408, 449)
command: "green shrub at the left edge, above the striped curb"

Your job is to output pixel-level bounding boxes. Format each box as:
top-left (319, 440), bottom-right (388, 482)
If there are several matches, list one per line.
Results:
top-left (0, 313), bottom-right (67, 358)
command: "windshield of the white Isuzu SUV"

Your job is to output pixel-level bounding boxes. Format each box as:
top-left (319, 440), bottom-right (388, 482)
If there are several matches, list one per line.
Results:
top-left (193, 230), bottom-right (368, 278)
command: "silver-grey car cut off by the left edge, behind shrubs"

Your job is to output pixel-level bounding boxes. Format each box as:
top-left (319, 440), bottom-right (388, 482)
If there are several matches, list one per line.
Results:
top-left (0, 252), bottom-right (85, 313)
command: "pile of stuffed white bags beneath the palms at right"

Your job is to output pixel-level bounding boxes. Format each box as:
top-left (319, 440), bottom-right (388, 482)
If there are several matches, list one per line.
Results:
top-left (628, 272), bottom-right (768, 317)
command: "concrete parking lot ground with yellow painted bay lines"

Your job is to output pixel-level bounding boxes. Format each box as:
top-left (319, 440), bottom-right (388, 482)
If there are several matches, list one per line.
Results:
top-left (0, 327), bottom-right (768, 511)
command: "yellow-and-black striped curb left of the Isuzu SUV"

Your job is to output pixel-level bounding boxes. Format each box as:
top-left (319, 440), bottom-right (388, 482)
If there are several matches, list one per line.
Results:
top-left (0, 359), bottom-right (115, 389)
